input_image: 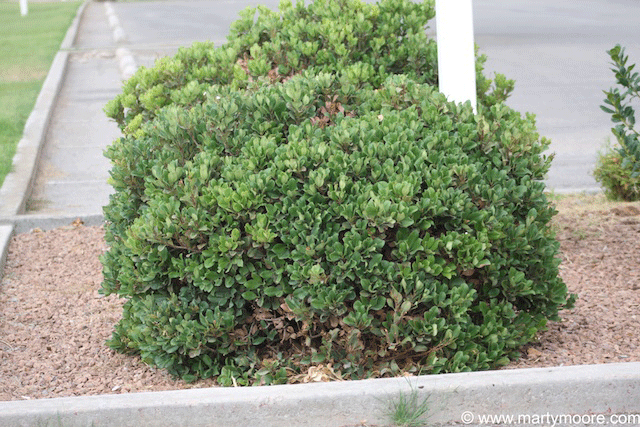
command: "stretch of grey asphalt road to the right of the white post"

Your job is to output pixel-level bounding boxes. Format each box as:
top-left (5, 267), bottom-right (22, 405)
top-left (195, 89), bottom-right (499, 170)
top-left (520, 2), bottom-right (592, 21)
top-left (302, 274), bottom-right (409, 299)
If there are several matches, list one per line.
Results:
top-left (473, 0), bottom-right (640, 191)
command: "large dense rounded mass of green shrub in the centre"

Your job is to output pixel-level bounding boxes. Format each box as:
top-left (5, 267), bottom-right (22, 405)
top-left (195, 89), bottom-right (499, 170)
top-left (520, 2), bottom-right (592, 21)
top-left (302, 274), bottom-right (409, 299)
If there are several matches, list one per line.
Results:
top-left (102, 0), bottom-right (573, 385)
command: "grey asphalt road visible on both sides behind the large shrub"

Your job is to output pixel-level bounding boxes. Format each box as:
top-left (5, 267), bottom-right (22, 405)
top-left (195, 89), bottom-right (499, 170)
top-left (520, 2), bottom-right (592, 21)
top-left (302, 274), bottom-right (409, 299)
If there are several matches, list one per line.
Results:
top-left (113, 0), bottom-right (640, 192)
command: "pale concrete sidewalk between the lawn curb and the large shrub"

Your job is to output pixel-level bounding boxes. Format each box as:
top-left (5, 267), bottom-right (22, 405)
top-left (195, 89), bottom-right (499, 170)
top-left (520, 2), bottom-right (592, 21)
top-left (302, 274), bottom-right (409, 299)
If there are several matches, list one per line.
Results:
top-left (25, 2), bottom-right (122, 217)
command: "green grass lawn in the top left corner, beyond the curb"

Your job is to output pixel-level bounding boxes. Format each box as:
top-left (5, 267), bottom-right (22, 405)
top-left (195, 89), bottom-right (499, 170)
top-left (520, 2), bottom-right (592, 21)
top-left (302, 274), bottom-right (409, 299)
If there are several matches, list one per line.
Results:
top-left (0, 0), bottom-right (80, 185)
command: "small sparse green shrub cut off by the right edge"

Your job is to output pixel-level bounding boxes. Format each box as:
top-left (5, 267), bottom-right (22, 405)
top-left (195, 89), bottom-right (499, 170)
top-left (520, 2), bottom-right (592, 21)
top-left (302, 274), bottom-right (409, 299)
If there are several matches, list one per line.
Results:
top-left (594, 45), bottom-right (640, 201)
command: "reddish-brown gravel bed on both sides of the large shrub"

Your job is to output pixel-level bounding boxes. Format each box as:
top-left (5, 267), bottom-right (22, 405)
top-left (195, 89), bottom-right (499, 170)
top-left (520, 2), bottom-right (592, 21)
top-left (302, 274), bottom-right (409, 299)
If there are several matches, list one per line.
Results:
top-left (0, 195), bottom-right (640, 400)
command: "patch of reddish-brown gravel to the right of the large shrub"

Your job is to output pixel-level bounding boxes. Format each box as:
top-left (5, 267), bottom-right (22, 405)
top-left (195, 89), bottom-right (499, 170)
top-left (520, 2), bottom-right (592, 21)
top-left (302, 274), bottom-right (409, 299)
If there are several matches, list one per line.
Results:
top-left (509, 195), bottom-right (640, 368)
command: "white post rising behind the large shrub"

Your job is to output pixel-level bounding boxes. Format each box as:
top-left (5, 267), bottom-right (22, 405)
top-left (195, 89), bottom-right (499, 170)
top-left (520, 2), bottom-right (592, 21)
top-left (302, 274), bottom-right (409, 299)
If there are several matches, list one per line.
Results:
top-left (436, 0), bottom-right (477, 112)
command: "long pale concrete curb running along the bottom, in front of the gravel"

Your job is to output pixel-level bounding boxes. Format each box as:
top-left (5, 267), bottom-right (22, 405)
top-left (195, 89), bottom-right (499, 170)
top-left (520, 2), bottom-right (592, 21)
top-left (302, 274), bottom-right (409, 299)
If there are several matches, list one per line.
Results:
top-left (0, 363), bottom-right (640, 427)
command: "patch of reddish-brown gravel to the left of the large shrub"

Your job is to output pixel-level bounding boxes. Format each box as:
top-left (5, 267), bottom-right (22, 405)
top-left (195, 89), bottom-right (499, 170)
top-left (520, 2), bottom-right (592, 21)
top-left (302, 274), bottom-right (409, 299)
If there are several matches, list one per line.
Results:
top-left (0, 225), bottom-right (218, 400)
